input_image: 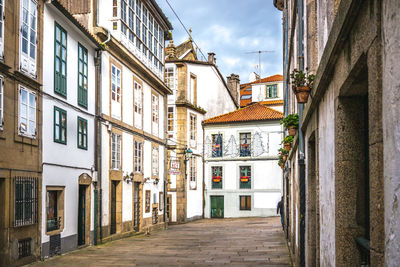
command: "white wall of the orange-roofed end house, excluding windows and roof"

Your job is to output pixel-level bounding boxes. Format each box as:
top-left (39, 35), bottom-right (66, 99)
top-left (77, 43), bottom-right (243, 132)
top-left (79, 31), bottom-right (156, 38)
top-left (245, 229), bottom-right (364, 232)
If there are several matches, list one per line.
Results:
top-left (204, 120), bottom-right (282, 218)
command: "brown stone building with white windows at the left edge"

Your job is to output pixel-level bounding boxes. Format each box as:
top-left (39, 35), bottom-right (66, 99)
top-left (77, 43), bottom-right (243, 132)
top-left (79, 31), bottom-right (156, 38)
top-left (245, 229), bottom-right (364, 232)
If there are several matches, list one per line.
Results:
top-left (0, 0), bottom-right (43, 266)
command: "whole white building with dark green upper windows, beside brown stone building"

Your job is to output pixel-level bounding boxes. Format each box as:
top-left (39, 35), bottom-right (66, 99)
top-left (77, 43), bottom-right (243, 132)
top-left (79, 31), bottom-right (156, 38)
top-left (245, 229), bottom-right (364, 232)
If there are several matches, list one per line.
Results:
top-left (41, 2), bottom-right (101, 257)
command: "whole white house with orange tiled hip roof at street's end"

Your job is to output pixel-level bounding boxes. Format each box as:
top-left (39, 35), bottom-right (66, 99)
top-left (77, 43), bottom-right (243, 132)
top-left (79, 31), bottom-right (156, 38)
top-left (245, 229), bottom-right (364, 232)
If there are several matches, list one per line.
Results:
top-left (203, 103), bottom-right (283, 218)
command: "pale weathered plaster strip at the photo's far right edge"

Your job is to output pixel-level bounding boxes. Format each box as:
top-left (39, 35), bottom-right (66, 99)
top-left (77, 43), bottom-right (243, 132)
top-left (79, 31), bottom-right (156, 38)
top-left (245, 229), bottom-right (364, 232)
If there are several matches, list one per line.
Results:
top-left (382, 0), bottom-right (400, 266)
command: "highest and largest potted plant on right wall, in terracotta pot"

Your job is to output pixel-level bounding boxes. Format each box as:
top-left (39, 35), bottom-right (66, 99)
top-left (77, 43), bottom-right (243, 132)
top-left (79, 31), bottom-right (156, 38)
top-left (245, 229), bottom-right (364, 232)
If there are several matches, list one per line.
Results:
top-left (290, 69), bottom-right (315, 104)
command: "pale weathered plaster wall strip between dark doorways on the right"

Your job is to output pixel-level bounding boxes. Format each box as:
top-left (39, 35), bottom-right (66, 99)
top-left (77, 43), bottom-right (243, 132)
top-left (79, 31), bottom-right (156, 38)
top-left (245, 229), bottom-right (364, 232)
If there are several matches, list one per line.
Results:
top-left (318, 90), bottom-right (335, 266)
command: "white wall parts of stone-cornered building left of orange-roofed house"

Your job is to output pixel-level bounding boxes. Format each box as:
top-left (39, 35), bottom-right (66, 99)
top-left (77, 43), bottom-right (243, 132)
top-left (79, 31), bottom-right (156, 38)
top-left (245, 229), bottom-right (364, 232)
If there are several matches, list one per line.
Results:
top-left (165, 61), bottom-right (236, 222)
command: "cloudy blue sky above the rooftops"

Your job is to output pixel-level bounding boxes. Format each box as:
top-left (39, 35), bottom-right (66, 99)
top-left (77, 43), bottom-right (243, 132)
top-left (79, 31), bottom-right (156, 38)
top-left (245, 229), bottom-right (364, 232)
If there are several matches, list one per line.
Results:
top-left (156, 0), bottom-right (282, 83)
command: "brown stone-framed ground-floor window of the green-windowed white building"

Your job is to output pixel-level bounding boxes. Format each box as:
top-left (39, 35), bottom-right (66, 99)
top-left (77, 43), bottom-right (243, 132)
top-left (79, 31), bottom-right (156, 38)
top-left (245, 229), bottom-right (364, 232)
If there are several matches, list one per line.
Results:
top-left (46, 187), bottom-right (64, 232)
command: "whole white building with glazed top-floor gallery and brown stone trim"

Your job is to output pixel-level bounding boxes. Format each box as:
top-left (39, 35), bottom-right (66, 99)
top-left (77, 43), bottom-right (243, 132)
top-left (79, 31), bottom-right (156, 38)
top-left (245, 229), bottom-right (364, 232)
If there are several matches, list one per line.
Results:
top-left (94, 0), bottom-right (172, 240)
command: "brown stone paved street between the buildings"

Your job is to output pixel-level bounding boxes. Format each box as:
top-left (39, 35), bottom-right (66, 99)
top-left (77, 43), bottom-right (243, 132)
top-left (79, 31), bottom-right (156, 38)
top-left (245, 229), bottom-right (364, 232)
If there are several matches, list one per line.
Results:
top-left (29, 217), bottom-right (291, 267)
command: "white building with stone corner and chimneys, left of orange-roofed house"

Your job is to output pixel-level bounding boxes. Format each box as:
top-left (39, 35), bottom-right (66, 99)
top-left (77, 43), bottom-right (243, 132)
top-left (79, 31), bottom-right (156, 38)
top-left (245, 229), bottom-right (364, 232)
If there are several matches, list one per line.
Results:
top-left (165, 39), bottom-right (239, 223)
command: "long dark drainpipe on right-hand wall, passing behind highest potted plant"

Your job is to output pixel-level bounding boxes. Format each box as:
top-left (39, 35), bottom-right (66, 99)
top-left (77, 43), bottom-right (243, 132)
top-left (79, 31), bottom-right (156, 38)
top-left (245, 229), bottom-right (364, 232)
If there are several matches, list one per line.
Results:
top-left (297, 0), bottom-right (306, 267)
